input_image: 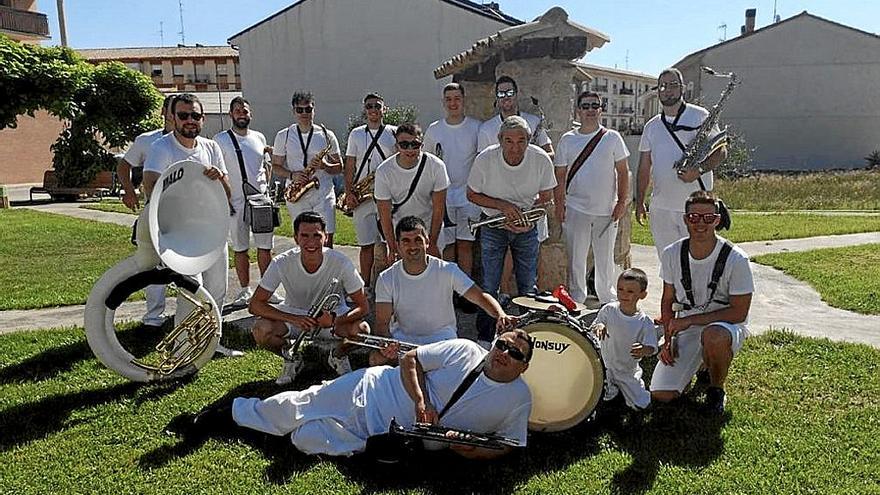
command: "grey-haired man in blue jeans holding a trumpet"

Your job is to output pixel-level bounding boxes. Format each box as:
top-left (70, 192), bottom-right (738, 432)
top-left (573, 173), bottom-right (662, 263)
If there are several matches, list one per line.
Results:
top-left (467, 115), bottom-right (556, 343)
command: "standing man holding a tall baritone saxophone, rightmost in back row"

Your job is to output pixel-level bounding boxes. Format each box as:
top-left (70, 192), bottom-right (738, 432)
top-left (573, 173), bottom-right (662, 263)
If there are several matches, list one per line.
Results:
top-left (636, 68), bottom-right (727, 256)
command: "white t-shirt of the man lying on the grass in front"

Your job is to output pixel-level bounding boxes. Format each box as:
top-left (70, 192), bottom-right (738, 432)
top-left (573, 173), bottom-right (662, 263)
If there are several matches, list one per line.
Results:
top-left (364, 339), bottom-right (532, 446)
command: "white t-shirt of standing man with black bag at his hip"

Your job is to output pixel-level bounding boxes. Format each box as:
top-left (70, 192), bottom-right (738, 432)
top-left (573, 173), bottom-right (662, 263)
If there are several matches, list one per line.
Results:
top-left (214, 129), bottom-right (269, 205)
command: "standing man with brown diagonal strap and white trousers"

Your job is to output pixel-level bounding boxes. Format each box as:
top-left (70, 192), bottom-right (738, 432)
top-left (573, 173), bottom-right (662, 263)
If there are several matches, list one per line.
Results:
top-left (555, 91), bottom-right (629, 304)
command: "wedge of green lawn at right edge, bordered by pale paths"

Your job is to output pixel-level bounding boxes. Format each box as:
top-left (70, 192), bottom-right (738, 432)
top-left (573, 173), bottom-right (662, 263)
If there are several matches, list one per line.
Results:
top-left (754, 244), bottom-right (880, 315)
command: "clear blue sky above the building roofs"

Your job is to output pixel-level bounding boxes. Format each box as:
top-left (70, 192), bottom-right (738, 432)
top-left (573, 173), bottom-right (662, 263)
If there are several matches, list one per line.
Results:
top-left (38, 0), bottom-right (880, 74)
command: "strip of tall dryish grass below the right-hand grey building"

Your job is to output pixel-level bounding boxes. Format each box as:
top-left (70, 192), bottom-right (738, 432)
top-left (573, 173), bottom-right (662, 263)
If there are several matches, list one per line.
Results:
top-left (715, 170), bottom-right (880, 211)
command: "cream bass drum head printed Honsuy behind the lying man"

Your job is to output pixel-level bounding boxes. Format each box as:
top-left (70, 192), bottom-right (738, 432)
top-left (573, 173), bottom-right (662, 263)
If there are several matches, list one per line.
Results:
top-left (522, 321), bottom-right (605, 432)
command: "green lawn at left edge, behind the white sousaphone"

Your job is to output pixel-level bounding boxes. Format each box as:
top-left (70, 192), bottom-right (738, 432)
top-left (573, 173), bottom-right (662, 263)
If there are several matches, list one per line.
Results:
top-left (0, 209), bottom-right (134, 310)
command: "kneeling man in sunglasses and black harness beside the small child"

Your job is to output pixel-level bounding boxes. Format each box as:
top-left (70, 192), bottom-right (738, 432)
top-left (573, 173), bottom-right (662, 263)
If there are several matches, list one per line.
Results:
top-left (651, 191), bottom-right (755, 413)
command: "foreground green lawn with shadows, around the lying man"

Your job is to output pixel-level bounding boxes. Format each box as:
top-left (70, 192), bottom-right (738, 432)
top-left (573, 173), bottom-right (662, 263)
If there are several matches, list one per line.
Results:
top-left (0, 328), bottom-right (880, 495)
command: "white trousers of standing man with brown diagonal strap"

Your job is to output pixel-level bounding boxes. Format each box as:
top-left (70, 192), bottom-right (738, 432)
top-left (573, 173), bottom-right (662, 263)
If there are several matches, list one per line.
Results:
top-left (562, 208), bottom-right (618, 304)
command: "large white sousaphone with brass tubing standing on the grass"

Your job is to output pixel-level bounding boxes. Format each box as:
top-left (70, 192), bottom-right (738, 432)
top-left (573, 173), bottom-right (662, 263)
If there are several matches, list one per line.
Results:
top-left (85, 160), bottom-right (229, 382)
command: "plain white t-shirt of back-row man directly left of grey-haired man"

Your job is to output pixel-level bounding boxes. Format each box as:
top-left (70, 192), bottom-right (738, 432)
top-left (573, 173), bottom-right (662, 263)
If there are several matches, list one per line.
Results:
top-left (424, 117), bottom-right (480, 206)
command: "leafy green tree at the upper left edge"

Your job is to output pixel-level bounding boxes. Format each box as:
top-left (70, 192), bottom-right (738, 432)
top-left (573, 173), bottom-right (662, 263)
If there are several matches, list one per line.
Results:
top-left (0, 35), bottom-right (162, 187)
